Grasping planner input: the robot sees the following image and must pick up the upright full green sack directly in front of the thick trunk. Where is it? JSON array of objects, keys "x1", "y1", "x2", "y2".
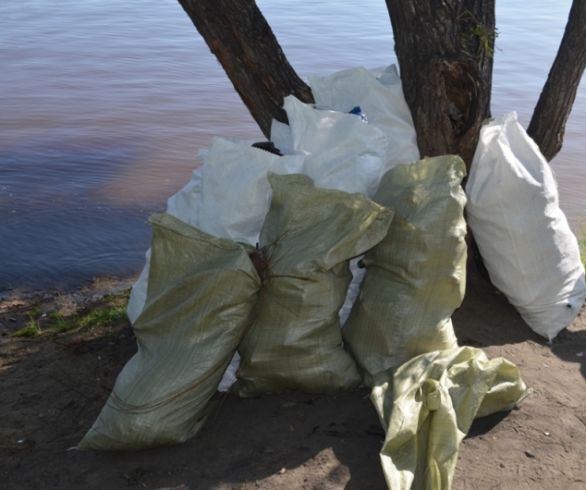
[{"x1": 343, "y1": 156, "x2": 466, "y2": 386}]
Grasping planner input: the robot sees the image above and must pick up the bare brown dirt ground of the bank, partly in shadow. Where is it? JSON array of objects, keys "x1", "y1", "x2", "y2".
[{"x1": 0, "y1": 268, "x2": 586, "y2": 490}]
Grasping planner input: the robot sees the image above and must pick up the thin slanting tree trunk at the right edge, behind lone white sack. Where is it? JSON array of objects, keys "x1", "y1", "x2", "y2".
[{"x1": 527, "y1": 0, "x2": 586, "y2": 160}]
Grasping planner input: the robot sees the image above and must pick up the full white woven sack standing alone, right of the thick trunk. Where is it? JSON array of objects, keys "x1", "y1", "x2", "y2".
[{"x1": 466, "y1": 112, "x2": 586, "y2": 340}]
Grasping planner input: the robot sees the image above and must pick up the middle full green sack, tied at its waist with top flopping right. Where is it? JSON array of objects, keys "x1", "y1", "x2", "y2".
[{"x1": 235, "y1": 174, "x2": 393, "y2": 396}]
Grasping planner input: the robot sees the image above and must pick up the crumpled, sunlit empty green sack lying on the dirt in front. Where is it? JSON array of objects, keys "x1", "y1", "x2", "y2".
[{"x1": 371, "y1": 347, "x2": 527, "y2": 490}]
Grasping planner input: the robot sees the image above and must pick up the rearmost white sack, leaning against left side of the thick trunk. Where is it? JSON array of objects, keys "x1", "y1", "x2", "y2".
[{"x1": 309, "y1": 65, "x2": 419, "y2": 170}]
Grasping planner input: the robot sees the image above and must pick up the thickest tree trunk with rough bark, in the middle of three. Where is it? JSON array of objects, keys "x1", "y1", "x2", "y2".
[{"x1": 386, "y1": 0, "x2": 495, "y2": 166}]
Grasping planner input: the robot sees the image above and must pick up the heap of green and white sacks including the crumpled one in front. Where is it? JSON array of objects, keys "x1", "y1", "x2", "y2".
[{"x1": 79, "y1": 67, "x2": 586, "y2": 489}]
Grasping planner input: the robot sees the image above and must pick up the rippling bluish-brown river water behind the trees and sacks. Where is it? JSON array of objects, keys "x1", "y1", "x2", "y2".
[{"x1": 0, "y1": 0, "x2": 586, "y2": 292}]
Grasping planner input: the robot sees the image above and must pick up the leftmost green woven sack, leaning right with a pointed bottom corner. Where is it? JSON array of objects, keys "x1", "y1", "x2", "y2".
[{"x1": 78, "y1": 214, "x2": 260, "y2": 450}]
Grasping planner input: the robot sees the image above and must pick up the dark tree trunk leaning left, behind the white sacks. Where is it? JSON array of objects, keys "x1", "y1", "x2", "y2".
[{"x1": 178, "y1": 0, "x2": 313, "y2": 137}]
